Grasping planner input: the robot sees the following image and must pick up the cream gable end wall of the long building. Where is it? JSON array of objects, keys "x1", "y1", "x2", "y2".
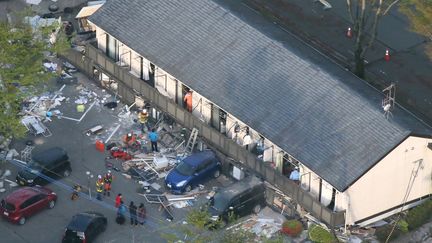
[{"x1": 337, "y1": 136, "x2": 432, "y2": 224}]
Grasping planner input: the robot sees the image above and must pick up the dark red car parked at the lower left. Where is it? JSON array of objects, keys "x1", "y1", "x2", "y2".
[{"x1": 0, "y1": 186, "x2": 57, "y2": 225}]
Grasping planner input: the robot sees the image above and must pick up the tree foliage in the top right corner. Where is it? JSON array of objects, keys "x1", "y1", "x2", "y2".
[{"x1": 399, "y1": 0, "x2": 432, "y2": 60}]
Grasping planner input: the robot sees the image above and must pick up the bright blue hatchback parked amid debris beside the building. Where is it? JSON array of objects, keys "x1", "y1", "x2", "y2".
[{"x1": 165, "y1": 150, "x2": 221, "y2": 194}]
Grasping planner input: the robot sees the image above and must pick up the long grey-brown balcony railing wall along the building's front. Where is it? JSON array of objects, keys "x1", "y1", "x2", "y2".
[{"x1": 66, "y1": 45, "x2": 345, "y2": 227}]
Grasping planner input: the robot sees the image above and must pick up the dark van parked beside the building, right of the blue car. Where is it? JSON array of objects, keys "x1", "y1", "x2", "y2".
[{"x1": 208, "y1": 176, "x2": 265, "y2": 225}]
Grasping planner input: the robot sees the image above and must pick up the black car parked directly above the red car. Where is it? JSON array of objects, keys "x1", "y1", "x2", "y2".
[{"x1": 16, "y1": 147, "x2": 72, "y2": 186}]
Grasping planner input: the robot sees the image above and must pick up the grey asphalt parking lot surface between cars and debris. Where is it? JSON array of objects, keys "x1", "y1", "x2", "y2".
[{"x1": 0, "y1": 70, "x2": 231, "y2": 242}]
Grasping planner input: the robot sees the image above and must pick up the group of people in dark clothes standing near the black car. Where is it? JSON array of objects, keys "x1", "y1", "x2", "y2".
[{"x1": 115, "y1": 193, "x2": 146, "y2": 226}]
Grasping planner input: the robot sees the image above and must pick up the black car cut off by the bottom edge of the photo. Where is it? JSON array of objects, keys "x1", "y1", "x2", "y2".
[{"x1": 62, "y1": 212, "x2": 108, "y2": 243}]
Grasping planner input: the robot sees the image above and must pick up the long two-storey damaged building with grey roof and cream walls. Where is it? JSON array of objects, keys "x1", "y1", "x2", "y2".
[{"x1": 64, "y1": 0, "x2": 432, "y2": 226}]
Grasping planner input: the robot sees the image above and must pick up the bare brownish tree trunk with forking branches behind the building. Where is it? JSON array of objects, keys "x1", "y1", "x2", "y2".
[{"x1": 346, "y1": 0, "x2": 399, "y2": 78}]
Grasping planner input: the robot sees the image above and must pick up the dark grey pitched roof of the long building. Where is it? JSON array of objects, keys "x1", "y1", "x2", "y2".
[{"x1": 90, "y1": 0, "x2": 431, "y2": 191}]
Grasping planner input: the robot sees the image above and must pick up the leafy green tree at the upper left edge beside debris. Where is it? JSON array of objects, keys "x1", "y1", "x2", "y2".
[{"x1": 0, "y1": 9, "x2": 67, "y2": 137}]
